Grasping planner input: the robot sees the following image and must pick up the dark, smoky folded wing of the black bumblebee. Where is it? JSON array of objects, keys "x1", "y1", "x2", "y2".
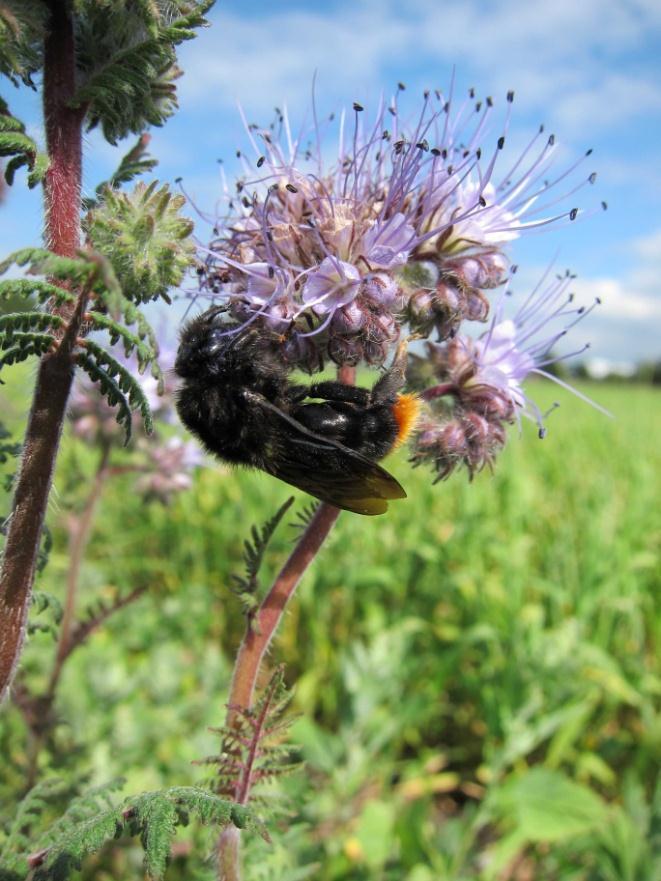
[{"x1": 248, "y1": 392, "x2": 406, "y2": 514}]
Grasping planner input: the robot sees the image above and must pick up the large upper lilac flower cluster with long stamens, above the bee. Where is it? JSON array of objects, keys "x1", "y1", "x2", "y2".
[{"x1": 187, "y1": 83, "x2": 594, "y2": 370}]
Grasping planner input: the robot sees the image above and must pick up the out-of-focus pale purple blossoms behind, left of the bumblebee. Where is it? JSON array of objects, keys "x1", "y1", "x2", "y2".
[{"x1": 68, "y1": 344, "x2": 204, "y2": 503}]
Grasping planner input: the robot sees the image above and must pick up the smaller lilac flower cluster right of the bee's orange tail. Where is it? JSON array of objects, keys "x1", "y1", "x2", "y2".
[{"x1": 411, "y1": 274, "x2": 608, "y2": 477}]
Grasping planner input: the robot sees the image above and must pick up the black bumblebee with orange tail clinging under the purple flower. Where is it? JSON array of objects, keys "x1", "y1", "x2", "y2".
[{"x1": 175, "y1": 309, "x2": 418, "y2": 514}]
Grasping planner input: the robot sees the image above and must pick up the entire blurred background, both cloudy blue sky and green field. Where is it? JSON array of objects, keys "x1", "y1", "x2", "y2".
[{"x1": 0, "y1": 0, "x2": 661, "y2": 881}]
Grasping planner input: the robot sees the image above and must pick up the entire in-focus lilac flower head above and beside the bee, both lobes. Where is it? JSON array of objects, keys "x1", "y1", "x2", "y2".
[{"x1": 188, "y1": 86, "x2": 595, "y2": 476}]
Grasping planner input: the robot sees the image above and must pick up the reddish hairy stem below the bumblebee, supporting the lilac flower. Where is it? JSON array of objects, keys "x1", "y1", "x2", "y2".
[{"x1": 218, "y1": 367, "x2": 356, "y2": 881}]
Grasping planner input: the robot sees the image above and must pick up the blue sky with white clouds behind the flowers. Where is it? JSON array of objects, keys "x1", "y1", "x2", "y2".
[{"x1": 0, "y1": 0, "x2": 661, "y2": 361}]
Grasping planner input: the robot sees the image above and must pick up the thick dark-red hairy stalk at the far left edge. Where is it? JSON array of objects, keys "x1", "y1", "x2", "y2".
[{"x1": 0, "y1": 0, "x2": 87, "y2": 699}]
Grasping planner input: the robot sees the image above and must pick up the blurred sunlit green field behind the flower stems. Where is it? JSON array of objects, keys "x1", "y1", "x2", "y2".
[{"x1": 0, "y1": 384, "x2": 661, "y2": 881}]
